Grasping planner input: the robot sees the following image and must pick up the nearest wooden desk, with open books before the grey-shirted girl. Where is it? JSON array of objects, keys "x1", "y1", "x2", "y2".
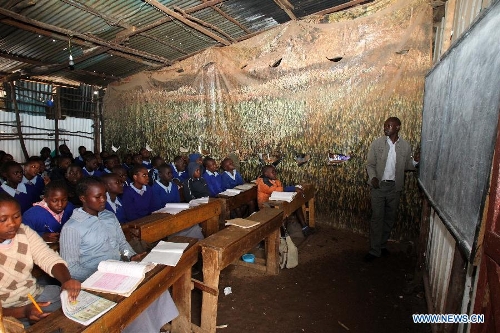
[{"x1": 26, "y1": 237, "x2": 200, "y2": 333}]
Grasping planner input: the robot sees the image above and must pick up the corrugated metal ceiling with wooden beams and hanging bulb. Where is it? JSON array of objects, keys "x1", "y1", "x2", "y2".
[{"x1": 0, "y1": 0, "x2": 373, "y2": 87}]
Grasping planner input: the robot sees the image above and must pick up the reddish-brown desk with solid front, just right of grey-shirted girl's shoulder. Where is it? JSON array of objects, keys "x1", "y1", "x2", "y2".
[{"x1": 122, "y1": 199, "x2": 222, "y2": 243}]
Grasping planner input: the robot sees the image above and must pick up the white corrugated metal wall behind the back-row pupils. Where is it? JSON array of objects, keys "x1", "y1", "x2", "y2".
[{"x1": 0, "y1": 111, "x2": 94, "y2": 162}]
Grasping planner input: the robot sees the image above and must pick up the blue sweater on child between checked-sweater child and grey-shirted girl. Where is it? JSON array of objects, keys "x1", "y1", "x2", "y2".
[{"x1": 23, "y1": 202, "x2": 75, "y2": 237}]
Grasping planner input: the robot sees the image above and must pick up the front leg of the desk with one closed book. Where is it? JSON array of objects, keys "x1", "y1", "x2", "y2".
[{"x1": 201, "y1": 248, "x2": 220, "y2": 333}]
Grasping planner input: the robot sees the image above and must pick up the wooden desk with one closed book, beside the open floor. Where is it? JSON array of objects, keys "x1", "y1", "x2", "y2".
[{"x1": 199, "y1": 208, "x2": 283, "y2": 332}]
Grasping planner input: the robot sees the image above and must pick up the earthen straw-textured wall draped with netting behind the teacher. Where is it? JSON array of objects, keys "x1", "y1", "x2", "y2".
[{"x1": 104, "y1": 0, "x2": 432, "y2": 238}]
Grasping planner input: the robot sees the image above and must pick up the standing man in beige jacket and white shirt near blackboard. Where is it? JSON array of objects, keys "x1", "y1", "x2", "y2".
[{"x1": 364, "y1": 117, "x2": 419, "y2": 262}]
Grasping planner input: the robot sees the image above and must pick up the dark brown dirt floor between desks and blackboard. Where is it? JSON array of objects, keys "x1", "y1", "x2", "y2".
[{"x1": 193, "y1": 220, "x2": 430, "y2": 333}]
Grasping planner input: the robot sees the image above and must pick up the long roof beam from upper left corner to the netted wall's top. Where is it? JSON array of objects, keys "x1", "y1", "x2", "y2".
[{"x1": 0, "y1": 8, "x2": 171, "y2": 65}]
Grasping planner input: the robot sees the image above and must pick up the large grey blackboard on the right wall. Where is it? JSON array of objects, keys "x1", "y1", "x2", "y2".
[{"x1": 419, "y1": 1, "x2": 500, "y2": 258}]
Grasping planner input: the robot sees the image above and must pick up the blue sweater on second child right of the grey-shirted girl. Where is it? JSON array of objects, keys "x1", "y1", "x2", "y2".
[{"x1": 122, "y1": 184, "x2": 153, "y2": 221}]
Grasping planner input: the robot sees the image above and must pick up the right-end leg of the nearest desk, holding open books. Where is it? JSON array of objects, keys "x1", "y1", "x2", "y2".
[{"x1": 172, "y1": 269, "x2": 191, "y2": 333}]
